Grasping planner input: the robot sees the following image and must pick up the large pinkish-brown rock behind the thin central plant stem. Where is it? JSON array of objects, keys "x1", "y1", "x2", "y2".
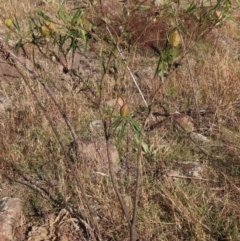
[{"x1": 71, "y1": 137, "x2": 119, "y2": 174}]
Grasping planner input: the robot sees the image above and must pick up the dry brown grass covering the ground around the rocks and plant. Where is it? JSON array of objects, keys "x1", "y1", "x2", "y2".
[{"x1": 0, "y1": 1, "x2": 240, "y2": 241}]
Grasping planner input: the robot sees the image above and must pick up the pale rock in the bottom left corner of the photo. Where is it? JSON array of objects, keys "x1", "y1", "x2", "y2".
[{"x1": 0, "y1": 197, "x2": 21, "y2": 241}]
